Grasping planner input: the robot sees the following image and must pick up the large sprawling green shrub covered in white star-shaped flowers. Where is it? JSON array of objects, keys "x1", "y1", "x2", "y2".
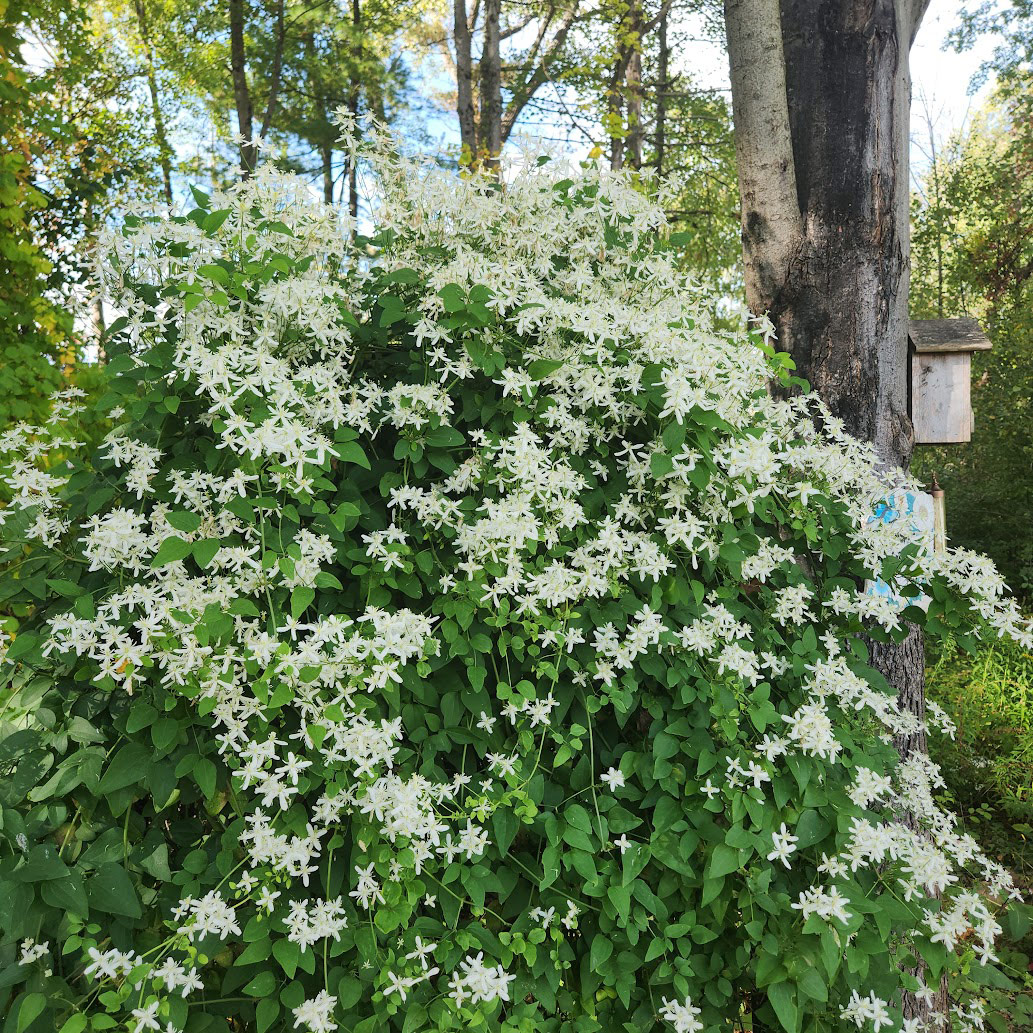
[{"x1": 0, "y1": 129, "x2": 1030, "y2": 1033}]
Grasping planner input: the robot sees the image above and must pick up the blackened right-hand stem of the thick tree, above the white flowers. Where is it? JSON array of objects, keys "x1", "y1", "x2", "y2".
[{"x1": 776, "y1": 0, "x2": 913, "y2": 468}]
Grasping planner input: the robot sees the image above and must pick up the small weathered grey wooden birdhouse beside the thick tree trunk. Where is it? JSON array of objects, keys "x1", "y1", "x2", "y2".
[{"x1": 908, "y1": 318, "x2": 991, "y2": 445}]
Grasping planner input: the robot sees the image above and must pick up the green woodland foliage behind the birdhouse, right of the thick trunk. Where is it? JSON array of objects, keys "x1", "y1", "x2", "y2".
[{"x1": 911, "y1": 99, "x2": 1033, "y2": 596}]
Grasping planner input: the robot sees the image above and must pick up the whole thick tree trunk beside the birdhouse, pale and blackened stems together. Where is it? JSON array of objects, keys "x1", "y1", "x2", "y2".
[{"x1": 725, "y1": 0, "x2": 945, "y2": 1015}]
